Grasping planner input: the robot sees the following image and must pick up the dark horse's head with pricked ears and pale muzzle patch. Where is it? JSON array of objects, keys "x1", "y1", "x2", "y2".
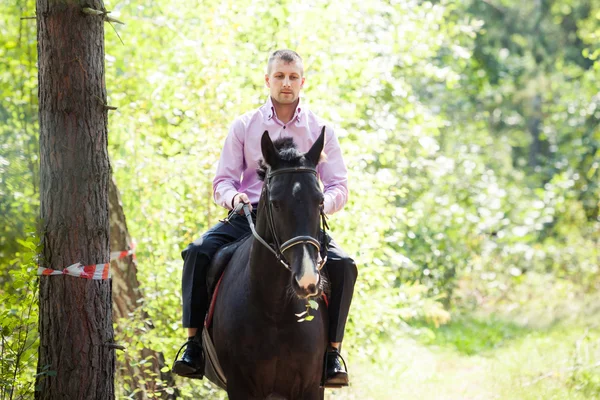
[{"x1": 259, "y1": 127, "x2": 325, "y2": 298}]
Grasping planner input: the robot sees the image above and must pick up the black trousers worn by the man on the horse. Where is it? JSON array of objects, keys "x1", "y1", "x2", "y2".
[{"x1": 181, "y1": 208, "x2": 358, "y2": 342}]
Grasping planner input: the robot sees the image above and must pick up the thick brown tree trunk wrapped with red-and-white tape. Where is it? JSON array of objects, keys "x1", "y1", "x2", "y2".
[{"x1": 35, "y1": 0, "x2": 115, "y2": 400}]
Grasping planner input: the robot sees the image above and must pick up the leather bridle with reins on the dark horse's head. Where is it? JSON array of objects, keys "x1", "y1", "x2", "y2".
[{"x1": 233, "y1": 167, "x2": 329, "y2": 271}]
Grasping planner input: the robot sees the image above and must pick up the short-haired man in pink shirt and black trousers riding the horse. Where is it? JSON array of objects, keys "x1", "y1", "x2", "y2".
[{"x1": 173, "y1": 50, "x2": 358, "y2": 386}]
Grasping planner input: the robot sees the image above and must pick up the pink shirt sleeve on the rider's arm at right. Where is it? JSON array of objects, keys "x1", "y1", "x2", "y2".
[{"x1": 317, "y1": 128, "x2": 348, "y2": 214}]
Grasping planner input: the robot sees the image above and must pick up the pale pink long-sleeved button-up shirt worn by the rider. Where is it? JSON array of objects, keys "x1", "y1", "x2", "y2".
[{"x1": 213, "y1": 97, "x2": 348, "y2": 214}]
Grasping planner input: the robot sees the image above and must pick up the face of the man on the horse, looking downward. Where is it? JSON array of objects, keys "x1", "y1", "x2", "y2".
[{"x1": 265, "y1": 59, "x2": 304, "y2": 104}]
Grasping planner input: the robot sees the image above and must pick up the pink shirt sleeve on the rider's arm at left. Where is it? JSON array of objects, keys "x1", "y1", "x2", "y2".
[{"x1": 213, "y1": 119, "x2": 245, "y2": 210}]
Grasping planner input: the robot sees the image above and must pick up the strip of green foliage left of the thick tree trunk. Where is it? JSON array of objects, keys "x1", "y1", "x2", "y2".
[{"x1": 0, "y1": 1, "x2": 39, "y2": 399}]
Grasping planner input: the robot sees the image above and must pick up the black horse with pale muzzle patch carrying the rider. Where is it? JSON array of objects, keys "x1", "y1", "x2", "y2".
[{"x1": 205, "y1": 128, "x2": 328, "y2": 400}]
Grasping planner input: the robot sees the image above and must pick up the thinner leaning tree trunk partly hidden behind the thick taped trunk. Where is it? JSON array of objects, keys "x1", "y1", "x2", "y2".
[{"x1": 108, "y1": 179, "x2": 178, "y2": 400}]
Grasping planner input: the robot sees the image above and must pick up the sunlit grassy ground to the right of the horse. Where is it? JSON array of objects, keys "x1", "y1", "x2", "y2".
[{"x1": 326, "y1": 276, "x2": 600, "y2": 400}]
